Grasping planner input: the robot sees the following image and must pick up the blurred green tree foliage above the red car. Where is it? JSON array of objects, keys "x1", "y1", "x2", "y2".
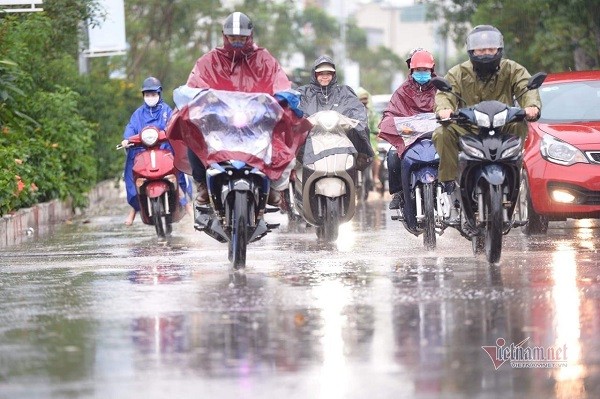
[{"x1": 426, "y1": 0, "x2": 600, "y2": 72}]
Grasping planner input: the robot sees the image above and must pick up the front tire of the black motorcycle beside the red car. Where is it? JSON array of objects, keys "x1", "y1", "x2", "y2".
[{"x1": 484, "y1": 184, "x2": 504, "y2": 263}]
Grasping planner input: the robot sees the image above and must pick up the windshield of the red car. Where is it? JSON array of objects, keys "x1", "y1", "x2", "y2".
[{"x1": 539, "y1": 81, "x2": 600, "y2": 122}]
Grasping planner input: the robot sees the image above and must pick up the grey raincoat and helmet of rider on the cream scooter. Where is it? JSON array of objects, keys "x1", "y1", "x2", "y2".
[{"x1": 298, "y1": 56, "x2": 375, "y2": 158}]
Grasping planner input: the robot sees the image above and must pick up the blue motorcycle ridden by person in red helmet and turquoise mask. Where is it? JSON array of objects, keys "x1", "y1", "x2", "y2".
[{"x1": 392, "y1": 112, "x2": 446, "y2": 250}]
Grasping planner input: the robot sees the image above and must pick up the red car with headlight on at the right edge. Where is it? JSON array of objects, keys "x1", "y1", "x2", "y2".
[{"x1": 520, "y1": 70, "x2": 600, "y2": 234}]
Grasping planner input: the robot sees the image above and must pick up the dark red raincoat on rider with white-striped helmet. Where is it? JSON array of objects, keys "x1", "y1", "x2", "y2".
[{"x1": 167, "y1": 36, "x2": 312, "y2": 180}]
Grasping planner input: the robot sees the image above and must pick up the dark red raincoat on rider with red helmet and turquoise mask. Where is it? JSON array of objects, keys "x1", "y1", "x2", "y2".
[{"x1": 378, "y1": 74, "x2": 436, "y2": 156}]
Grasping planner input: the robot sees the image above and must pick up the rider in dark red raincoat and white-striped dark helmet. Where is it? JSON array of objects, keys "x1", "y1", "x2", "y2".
[{"x1": 167, "y1": 12, "x2": 311, "y2": 206}]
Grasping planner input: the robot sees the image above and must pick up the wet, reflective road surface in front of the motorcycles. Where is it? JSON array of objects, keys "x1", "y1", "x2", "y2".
[{"x1": 0, "y1": 198, "x2": 600, "y2": 399}]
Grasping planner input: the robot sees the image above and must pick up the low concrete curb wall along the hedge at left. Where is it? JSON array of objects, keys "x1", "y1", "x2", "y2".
[{"x1": 0, "y1": 180, "x2": 122, "y2": 248}]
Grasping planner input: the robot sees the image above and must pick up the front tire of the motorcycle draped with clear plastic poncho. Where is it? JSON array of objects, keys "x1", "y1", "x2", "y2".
[{"x1": 228, "y1": 191, "x2": 249, "y2": 270}]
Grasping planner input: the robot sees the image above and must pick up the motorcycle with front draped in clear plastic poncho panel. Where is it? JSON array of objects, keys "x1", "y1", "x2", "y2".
[{"x1": 168, "y1": 88, "x2": 308, "y2": 270}]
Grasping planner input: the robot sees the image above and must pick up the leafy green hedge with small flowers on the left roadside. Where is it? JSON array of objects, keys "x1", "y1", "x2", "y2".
[{"x1": 0, "y1": 4, "x2": 131, "y2": 216}]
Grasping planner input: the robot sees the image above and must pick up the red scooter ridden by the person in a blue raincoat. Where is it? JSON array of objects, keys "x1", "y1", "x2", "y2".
[{"x1": 116, "y1": 126, "x2": 186, "y2": 238}]
